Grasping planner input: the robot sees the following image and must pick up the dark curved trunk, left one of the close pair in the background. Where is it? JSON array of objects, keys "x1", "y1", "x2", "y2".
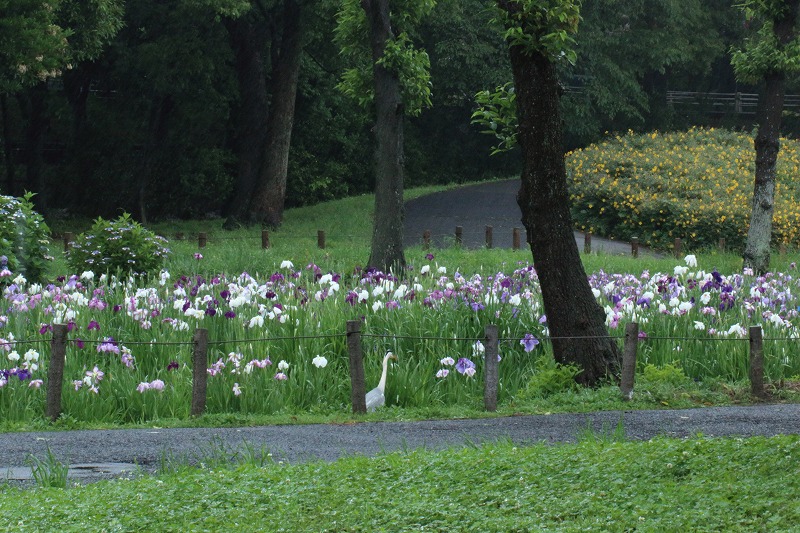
[{"x1": 224, "y1": 18, "x2": 269, "y2": 229}]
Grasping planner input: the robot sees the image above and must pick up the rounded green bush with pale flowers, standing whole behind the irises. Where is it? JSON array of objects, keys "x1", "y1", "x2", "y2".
[{"x1": 67, "y1": 213, "x2": 169, "y2": 275}]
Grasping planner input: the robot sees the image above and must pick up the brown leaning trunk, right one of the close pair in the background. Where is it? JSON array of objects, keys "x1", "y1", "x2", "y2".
[{"x1": 248, "y1": 0, "x2": 303, "y2": 228}]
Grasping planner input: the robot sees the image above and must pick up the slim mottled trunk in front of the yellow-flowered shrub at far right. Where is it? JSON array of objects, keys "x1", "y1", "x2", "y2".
[{"x1": 742, "y1": 0, "x2": 800, "y2": 274}]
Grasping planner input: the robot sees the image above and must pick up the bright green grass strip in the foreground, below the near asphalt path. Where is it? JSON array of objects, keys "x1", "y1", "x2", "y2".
[{"x1": 0, "y1": 431, "x2": 800, "y2": 532}]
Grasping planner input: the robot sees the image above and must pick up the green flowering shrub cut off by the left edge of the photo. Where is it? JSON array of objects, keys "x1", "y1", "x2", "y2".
[{"x1": 0, "y1": 193, "x2": 53, "y2": 282}]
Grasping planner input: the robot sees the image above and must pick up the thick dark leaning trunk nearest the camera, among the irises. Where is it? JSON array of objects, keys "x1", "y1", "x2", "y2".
[{"x1": 510, "y1": 46, "x2": 619, "y2": 385}]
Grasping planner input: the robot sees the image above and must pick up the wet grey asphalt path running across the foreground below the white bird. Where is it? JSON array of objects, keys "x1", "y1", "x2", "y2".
[{"x1": 0, "y1": 404, "x2": 800, "y2": 483}]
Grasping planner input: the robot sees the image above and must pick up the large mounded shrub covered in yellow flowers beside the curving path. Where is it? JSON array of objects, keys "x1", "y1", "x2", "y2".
[{"x1": 567, "y1": 128, "x2": 800, "y2": 254}]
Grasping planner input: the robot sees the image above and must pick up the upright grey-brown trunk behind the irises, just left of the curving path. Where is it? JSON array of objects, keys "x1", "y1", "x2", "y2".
[{"x1": 361, "y1": 0, "x2": 406, "y2": 275}]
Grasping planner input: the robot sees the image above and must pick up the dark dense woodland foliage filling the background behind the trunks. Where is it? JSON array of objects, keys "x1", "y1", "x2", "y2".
[{"x1": 0, "y1": 0, "x2": 776, "y2": 220}]
